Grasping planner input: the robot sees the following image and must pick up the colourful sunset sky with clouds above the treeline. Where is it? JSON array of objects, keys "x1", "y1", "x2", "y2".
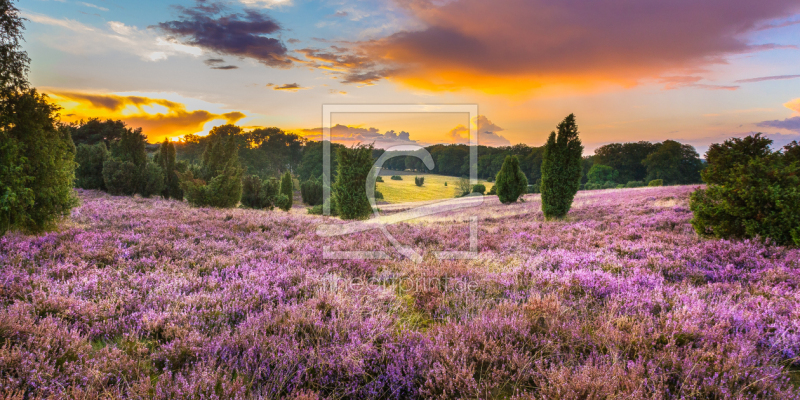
[{"x1": 17, "y1": 0, "x2": 800, "y2": 154}]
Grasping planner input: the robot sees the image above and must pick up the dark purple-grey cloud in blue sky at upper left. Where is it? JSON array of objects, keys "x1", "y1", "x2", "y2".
[{"x1": 156, "y1": 1, "x2": 292, "y2": 68}]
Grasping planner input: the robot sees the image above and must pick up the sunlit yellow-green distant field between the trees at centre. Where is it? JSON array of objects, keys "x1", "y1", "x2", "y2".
[{"x1": 378, "y1": 171, "x2": 494, "y2": 203}]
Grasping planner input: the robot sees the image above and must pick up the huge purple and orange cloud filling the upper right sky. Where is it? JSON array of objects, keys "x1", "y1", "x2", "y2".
[{"x1": 346, "y1": 0, "x2": 800, "y2": 92}]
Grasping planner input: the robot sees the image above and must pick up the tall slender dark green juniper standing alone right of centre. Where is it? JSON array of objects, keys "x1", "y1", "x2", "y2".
[{"x1": 540, "y1": 114, "x2": 583, "y2": 219}]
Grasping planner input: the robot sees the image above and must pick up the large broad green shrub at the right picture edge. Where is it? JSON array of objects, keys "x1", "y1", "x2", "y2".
[{"x1": 690, "y1": 134, "x2": 800, "y2": 246}]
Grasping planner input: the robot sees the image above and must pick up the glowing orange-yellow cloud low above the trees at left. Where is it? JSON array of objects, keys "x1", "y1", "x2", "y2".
[{"x1": 48, "y1": 90, "x2": 246, "y2": 142}]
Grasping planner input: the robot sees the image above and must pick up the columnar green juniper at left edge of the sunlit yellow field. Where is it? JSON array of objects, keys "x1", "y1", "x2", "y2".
[{"x1": 331, "y1": 144, "x2": 373, "y2": 219}]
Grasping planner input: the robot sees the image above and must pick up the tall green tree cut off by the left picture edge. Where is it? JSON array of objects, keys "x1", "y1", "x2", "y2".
[{"x1": 0, "y1": 0, "x2": 77, "y2": 235}]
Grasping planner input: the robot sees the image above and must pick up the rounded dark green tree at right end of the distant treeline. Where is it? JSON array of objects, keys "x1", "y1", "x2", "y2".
[{"x1": 642, "y1": 140, "x2": 703, "y2": 184}]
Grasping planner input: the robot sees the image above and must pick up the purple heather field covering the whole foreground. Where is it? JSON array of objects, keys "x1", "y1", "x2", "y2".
[{"x1": 0, "y1": 186, "x2": 800, "y2": 399}]
